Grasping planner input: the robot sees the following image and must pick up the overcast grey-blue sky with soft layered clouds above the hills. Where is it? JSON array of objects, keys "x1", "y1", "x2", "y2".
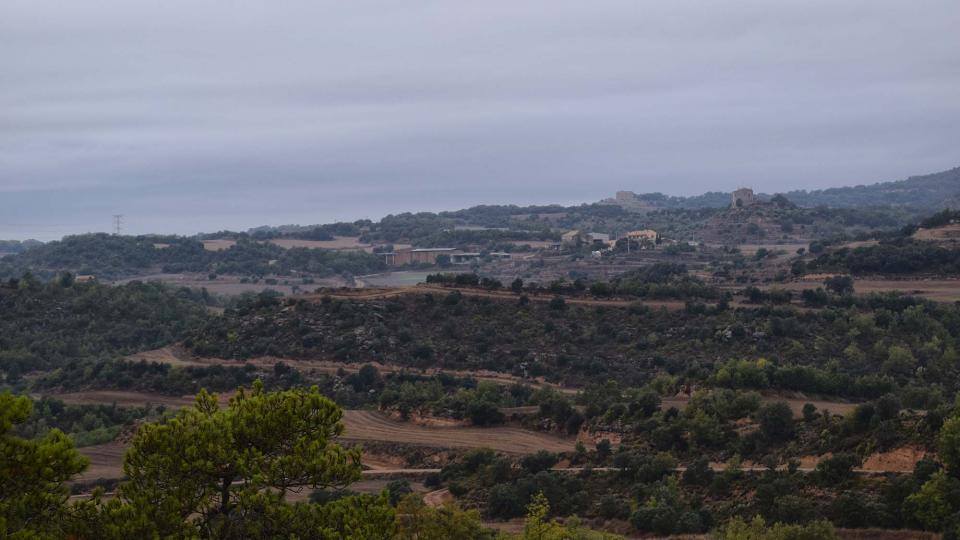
[{"x1": 0, "y1": 0, "x2": 960, "y2": 240}]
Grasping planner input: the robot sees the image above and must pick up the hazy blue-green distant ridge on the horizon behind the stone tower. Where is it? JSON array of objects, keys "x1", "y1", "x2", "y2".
[{"x1": 601, "y1": 167, "x2": 960, "y2": 211}]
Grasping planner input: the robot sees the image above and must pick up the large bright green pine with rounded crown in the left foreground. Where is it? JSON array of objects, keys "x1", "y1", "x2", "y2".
[{"x1": 104, "y1": 381, "x2": 360, "y2": 538}]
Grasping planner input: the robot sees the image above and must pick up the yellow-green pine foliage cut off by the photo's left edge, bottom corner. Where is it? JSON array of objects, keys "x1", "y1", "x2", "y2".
[{"x1": 0, "y1": 393, "x2": 88, "y2": 538}]
